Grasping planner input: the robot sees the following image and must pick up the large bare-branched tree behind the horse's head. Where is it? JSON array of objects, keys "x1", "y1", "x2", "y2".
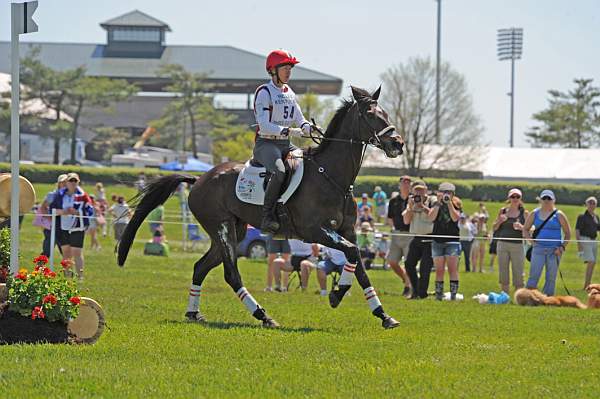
[{"x1": 381, "y1": 57, "x2": 483, "y2": 173}]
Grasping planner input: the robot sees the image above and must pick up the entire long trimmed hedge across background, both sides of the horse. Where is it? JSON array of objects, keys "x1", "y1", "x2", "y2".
[{"x1": 0, "y1": 163, "x2": 600, "y2": 205}]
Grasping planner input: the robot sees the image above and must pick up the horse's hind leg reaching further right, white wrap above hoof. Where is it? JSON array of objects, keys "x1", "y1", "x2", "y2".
[{"x1": 218, "y1": 221, "x2": 279, "y2": 327}]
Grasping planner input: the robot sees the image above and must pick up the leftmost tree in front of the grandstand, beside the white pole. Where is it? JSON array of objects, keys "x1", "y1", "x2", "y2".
[{"x1": 21, "y1": 48, "x2": 85, "y2": 164}]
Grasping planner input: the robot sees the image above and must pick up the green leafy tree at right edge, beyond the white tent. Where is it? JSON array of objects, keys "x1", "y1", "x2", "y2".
[{"x1": 525, "y1": 79, "x2": 600, "y2": 148}]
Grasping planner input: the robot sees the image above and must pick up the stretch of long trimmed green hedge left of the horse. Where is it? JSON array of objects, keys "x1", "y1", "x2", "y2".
[{"x1": 0, "y1": 163, "x2": 193, "y2": 185}]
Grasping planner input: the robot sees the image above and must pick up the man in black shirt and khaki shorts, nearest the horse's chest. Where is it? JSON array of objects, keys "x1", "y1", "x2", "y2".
[{"x1": 387, "y1": 176, "x2": 420, "y2": 297}]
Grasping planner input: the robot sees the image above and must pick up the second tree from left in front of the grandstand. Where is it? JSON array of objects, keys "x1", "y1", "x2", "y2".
[{"x1": 67, "y1": 76, "x2": 137, "y2": 161}]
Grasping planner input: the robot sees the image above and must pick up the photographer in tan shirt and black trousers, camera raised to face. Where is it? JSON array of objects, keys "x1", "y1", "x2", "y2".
[{"x1": 400, "y1": 181, "x2": 435, "y2": 299}]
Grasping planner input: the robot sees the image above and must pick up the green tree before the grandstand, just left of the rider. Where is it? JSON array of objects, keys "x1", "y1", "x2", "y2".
[{"x1": 155, "y1": 64, "x2": 212, "y2": 158}]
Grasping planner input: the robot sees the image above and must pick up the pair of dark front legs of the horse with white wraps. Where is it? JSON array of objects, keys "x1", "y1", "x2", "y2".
[{"x1": 320, "y1": 227, "x2": 399, "y2": 328}]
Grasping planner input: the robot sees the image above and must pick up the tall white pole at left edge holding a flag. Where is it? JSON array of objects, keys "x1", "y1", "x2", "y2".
[{"x1": 10, "y1": 3, "x2": 20, "y2": 275}]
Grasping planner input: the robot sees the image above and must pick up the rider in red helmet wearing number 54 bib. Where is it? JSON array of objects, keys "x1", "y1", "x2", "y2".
[{"x1": 253, "y1": 50, "x2": 312, "y2": 234}]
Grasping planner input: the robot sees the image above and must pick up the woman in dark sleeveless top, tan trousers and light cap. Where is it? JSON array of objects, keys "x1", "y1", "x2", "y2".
[{"x1": 494, "y1": 188, "x2": 529, "y2": 293}]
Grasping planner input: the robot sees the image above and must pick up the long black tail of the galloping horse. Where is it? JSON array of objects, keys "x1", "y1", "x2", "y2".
[{"x1": 117, "y1": 175, "x2": 196, "y2": 266}]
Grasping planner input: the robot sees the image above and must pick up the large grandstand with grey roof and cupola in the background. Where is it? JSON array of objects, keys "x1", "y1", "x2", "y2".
[{"x1": 0, "y1": 10, "x2": 342, "y2": 164}]
